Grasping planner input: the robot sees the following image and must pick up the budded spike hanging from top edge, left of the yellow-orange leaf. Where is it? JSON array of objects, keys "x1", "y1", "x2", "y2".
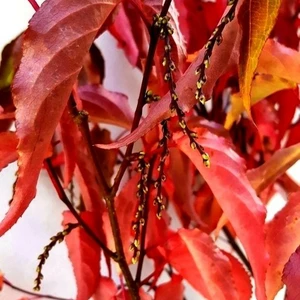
[{"x1": 195, "y1": 0, "x2": 238, "y2": 105}]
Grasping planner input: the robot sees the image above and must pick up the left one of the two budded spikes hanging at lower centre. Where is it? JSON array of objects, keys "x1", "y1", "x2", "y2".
[{"x1": 130, "y1": 152, "x2": 150, "y2": 264}]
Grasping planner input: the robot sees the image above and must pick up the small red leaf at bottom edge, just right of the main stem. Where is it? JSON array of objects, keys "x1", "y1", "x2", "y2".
[{"x1": 154, "y1": 274, "x2": 184, "y2": 300}]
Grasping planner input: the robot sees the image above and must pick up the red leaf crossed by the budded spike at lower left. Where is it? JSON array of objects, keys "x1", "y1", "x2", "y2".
[{"x1": 63, "y1": 211, "x2": 100, "y2": 300}]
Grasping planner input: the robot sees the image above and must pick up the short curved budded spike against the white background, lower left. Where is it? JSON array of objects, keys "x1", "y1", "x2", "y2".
[{"x1": 33, "y1": 224, "x2": 79, "y2": 291}]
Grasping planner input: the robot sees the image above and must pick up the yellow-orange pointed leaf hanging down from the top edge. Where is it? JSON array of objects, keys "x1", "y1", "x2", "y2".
[{"x1": 238, "y1": 0, "x2": 281, "y2": 115}]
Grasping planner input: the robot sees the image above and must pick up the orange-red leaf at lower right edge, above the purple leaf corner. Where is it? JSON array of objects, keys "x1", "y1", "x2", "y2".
[{"x1": 266, "y1": 192, "x2": 300, "y2": 299}]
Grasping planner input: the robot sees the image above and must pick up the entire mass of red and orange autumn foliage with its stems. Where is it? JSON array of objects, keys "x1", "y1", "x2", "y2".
[{"x1": 0, "y1": 0, "x2": 300, "y2": 300}]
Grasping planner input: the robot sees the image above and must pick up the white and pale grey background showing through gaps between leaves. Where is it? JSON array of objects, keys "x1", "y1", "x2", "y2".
[{"x1": 0, "y1": 0, "x2": 292, "y2": 300}]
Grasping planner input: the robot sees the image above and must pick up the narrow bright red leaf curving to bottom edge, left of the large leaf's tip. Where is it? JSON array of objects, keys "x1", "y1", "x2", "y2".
[{"x1": 222, "y1": 251, "x2": 252, "y2": 300}]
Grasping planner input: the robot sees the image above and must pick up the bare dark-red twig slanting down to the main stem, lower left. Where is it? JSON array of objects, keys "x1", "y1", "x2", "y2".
[{"x1": 44, "y1": 158, "x2": 117, "y2": 260}]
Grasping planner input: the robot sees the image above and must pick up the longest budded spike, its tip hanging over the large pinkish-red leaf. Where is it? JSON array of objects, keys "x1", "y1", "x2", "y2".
[{"x1": 154, "y1": 16, "x2": 210, "y2": 167}]
